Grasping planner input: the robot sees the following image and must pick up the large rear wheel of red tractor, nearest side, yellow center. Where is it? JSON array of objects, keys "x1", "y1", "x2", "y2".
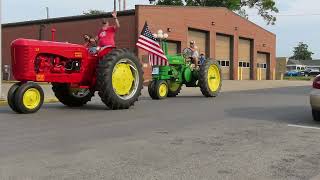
[{"x1": 97, "y1": 49, "x2": 143, "y2": 109}]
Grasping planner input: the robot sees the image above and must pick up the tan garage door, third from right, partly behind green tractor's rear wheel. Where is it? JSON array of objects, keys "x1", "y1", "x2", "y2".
[{"x1": 216, "y1": 35, "x2": 231, "y2": 79}]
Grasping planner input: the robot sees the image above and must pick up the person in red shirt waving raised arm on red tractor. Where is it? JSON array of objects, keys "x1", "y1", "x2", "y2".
[{"x1": 96, "y1": 11, "x2": 120, "y2": 48}]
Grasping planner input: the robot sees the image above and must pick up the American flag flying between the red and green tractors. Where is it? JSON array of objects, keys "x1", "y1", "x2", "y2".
[{"x1": 137, "y1": 22, "x2": 169, "y2": 66}]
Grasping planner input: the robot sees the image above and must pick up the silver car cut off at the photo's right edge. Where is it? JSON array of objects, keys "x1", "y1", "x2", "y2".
[{"x1": 310, "y1": 75, "x2": 320, "y2": 121}]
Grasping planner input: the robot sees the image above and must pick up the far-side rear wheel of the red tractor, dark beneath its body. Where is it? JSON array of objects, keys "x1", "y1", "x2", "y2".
[{"x1": 52, "y1": 83, "x2": 94, "y2": 107}]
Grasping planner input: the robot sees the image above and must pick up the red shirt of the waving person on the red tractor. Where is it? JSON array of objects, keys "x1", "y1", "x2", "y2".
[{"x1": 98, "y1": 26, "x2": 116, "y2": 47}]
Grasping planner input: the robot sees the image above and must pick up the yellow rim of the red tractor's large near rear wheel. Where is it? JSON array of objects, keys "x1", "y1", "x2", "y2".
[{"x1": 112, "y1": 63, "x2": 135, "y2": 96}]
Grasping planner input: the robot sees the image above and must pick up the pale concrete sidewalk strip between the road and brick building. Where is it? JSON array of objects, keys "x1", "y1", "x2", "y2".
[{"x1": 0, "y1": 80, "x2": 312, "y2": 105}]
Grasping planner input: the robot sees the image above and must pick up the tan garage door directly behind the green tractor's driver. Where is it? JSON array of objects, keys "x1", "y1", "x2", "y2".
[{"x1": 188, "y1": 30, "x2": 209, "y2": 55}]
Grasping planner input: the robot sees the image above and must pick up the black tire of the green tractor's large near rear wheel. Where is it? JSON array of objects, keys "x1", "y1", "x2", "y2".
[{"x1": 199, "y1": 60, "x2": 222, "y2": 97}]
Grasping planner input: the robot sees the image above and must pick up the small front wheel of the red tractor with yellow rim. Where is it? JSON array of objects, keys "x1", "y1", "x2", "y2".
[{"x1": 10, "y1": 82, "x2": 44, "y2": 114}]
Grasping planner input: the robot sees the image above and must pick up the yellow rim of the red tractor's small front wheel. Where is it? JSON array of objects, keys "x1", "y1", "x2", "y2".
[{"x1": 23, "y1": 88, "x2": 41, "y2": 110}]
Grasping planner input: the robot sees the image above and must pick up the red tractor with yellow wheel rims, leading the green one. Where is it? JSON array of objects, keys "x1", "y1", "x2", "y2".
[{"x1": 8, "y1": 39, "x2": 143, "y2": 114}]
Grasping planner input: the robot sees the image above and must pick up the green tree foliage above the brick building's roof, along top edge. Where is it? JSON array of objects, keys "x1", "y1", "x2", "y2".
[{"x1": 156, "y1": 0, "x2": 279, "y2": 24}]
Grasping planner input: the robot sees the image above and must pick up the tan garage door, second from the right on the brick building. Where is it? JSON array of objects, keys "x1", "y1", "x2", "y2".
[{"x1": 238, "y1": 39, "x2": 251, "y2": 80}]
